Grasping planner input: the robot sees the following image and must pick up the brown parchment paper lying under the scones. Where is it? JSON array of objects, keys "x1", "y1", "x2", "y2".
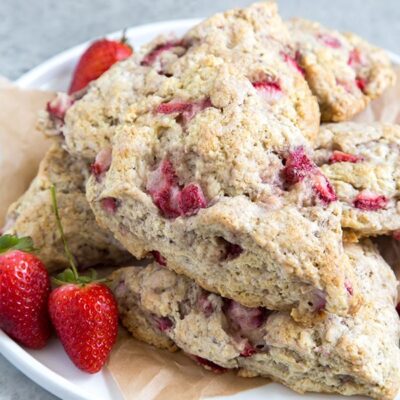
[{"x1": 0, "y1": 68, "x2": 400, "y2": 400}]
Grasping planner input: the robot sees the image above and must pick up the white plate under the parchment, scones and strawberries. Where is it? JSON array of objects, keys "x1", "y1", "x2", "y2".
[{"x1": 0, "y1": 19, "x2": 400, "y2": 400}]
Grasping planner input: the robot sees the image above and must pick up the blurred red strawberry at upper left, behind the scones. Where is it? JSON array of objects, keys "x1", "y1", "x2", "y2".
[{"x1": 68, "y1": 38, "x2": 133, "y2": 94}]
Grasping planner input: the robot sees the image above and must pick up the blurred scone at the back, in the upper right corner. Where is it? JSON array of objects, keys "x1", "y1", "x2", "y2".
[{"x1": 286, "y1": 18, "x2": 395, "y2": 122}]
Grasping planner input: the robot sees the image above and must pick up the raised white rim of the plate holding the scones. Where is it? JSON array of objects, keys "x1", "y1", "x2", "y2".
[{"x1": 4, "y1": 18, "x2": 400, "y2": 400}]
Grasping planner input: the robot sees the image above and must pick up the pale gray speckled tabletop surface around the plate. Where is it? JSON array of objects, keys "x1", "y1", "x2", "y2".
[{"x1": 0, "y1": 0, "x2": 400, "y2": 400}]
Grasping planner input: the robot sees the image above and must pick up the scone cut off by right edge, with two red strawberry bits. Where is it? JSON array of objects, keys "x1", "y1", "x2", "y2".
[{"x1": 314, "y1": 122, "x2": 400, "y2": 236}]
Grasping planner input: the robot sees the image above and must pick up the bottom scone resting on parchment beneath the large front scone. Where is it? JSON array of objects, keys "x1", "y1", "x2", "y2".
[{"x1": 113, "y1": 242, "x2": 400, "y2": 400}]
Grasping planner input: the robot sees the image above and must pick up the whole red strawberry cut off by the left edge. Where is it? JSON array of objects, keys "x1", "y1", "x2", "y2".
[{"x1": 0, "y1": 235, "x2": 51, "y2": 349}]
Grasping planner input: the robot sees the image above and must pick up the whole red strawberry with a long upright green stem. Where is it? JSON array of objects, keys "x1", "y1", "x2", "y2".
[{"x1": 49, "y1": 186, "x2": 118, "y2": 373}]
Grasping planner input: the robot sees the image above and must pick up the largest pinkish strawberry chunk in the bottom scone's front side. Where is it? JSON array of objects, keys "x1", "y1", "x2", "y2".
[{"x1": 224, "y1": 300, "x2": 267, "y2": 333}]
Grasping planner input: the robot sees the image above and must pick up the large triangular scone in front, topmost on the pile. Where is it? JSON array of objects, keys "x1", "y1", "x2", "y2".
[{"x1": 86, "y1": 55, "x2": 357, "y2": 322}]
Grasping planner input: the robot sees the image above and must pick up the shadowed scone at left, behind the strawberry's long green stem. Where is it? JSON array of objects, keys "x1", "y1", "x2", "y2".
[{"x1": 5, "y1": 142, "x2": 132, "y2": 272}]
